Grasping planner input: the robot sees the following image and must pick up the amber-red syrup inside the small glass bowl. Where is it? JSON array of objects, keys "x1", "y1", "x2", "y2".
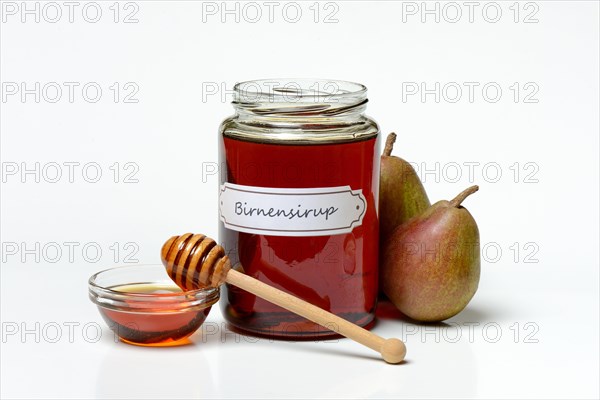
[{"x1": 98, "y1": 283, "x2": 210, "y2": 346}]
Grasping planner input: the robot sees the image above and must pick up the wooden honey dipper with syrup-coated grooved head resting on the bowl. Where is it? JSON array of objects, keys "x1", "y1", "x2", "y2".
[{"x1": 161, "y1": 233, "x2": 406, "y2": 364}]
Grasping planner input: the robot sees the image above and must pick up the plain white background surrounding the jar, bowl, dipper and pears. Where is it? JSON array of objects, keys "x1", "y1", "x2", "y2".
[{"x1": 0, "y1": 1, "x2": 599, "y2": 398}]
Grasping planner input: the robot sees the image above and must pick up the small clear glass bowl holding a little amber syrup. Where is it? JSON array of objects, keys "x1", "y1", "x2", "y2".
[{"x1": 88, "y1": 265, "x2": 219, "y2": 346}]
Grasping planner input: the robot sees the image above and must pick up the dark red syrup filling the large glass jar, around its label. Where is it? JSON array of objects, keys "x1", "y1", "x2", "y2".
[{"x1": 219, "y1": 137, "x2": 379, "y2": 338}]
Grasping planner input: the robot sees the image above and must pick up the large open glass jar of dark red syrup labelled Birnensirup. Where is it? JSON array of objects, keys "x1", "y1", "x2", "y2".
[{"x1": 219, "y1": 79, "x2": 380, "y2": 338}]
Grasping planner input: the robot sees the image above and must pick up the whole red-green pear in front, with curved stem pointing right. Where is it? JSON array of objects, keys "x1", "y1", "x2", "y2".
[{"x1": 381, "y1": 186, "x2": 481, "y2": 322}]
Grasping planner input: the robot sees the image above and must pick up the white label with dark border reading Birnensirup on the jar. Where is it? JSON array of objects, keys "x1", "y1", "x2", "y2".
[{"x1": 219, "y1": 182, "x2": 367, "y2": 236}]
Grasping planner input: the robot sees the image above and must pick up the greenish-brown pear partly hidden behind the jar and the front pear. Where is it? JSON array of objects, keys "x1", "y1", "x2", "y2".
[{"x1": 379, "y1": 132, "x2": 431, "y2": 245}]
